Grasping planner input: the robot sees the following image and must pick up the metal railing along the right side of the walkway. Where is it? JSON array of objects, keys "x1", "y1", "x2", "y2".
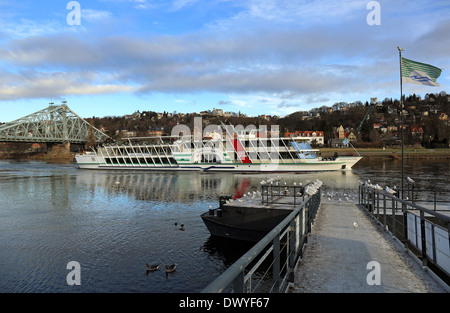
[{"x1": 358, "y1": 185, "x2": 450, "y2": 284}]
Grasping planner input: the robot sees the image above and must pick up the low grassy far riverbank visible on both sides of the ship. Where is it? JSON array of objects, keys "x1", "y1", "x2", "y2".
[{"x1": 0, "y1": 145, "x2": 450, "y2": 162}]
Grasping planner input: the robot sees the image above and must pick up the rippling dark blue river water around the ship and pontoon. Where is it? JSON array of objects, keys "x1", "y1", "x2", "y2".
[{"x1": 0, "y1": 159, "x2": 450, "y2": 293}]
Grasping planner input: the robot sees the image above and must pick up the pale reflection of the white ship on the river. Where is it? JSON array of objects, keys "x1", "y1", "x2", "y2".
[{"x1": 76, "y1": 171, "x2": 359, "y2": 203}]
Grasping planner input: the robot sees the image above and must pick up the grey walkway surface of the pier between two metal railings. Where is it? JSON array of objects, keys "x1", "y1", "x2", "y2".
[{"x1": 290, "y1": 201, "x2": 446, "y2": 293}]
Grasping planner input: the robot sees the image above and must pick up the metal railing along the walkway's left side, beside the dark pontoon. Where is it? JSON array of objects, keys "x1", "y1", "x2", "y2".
[{"x1": 202, "y1": 186, "x2": 320, "y2": 293}]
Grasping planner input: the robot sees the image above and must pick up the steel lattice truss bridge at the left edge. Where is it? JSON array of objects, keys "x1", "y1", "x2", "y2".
[{"x1": 0, "y1": 101, "x2": 109, "y2": 143}]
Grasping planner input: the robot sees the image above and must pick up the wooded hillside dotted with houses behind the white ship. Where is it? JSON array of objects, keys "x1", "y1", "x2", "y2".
[{"x1": 87, "y1": 92, "x2": 450, "y2": 148}]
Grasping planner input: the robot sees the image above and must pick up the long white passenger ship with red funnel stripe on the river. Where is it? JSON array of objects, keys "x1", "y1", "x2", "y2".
[{"x1": 75, "y1": 131, "x2": 362, "y2": 172}]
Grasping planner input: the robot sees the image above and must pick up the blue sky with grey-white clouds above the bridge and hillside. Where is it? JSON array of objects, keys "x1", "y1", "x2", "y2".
[{"x1": 0, "y1": 0, "x2": 450, "y2": 122}]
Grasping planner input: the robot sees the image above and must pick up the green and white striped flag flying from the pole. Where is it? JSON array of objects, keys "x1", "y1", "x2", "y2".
[{"x1": 402, "y1": 57, "x2": 442, "y2": 87}]
